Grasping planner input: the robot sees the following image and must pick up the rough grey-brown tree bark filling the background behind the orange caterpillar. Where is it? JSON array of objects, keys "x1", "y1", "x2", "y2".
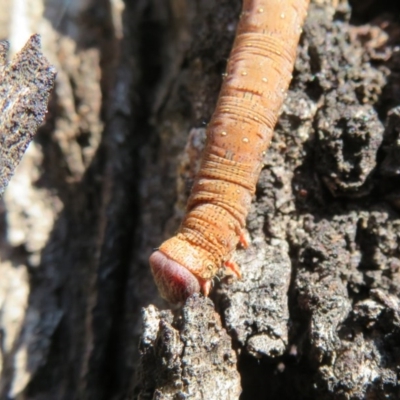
[{"x1": 0, "y1": 0, "x2": 400, "y2": 400}]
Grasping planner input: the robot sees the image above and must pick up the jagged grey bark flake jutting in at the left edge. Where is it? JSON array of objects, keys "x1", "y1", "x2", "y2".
[{"x1": 0, "y1": 35, "x2": 56, "y2": 196}]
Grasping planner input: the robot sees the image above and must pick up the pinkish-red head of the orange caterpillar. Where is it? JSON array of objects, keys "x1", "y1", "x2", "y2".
[{"x1": 149, "y1": 250, "x2": 201, "y2": 304}]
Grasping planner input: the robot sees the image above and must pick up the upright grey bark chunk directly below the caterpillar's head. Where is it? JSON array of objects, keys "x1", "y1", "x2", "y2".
[{"x1": 134, "y1": 295, "x2": 241, "y2": 400}]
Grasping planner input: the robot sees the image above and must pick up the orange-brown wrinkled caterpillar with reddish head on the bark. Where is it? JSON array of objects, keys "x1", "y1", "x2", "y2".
[{"x1": 149, "y1": 0, "x2": 309, "y2": 303}]
